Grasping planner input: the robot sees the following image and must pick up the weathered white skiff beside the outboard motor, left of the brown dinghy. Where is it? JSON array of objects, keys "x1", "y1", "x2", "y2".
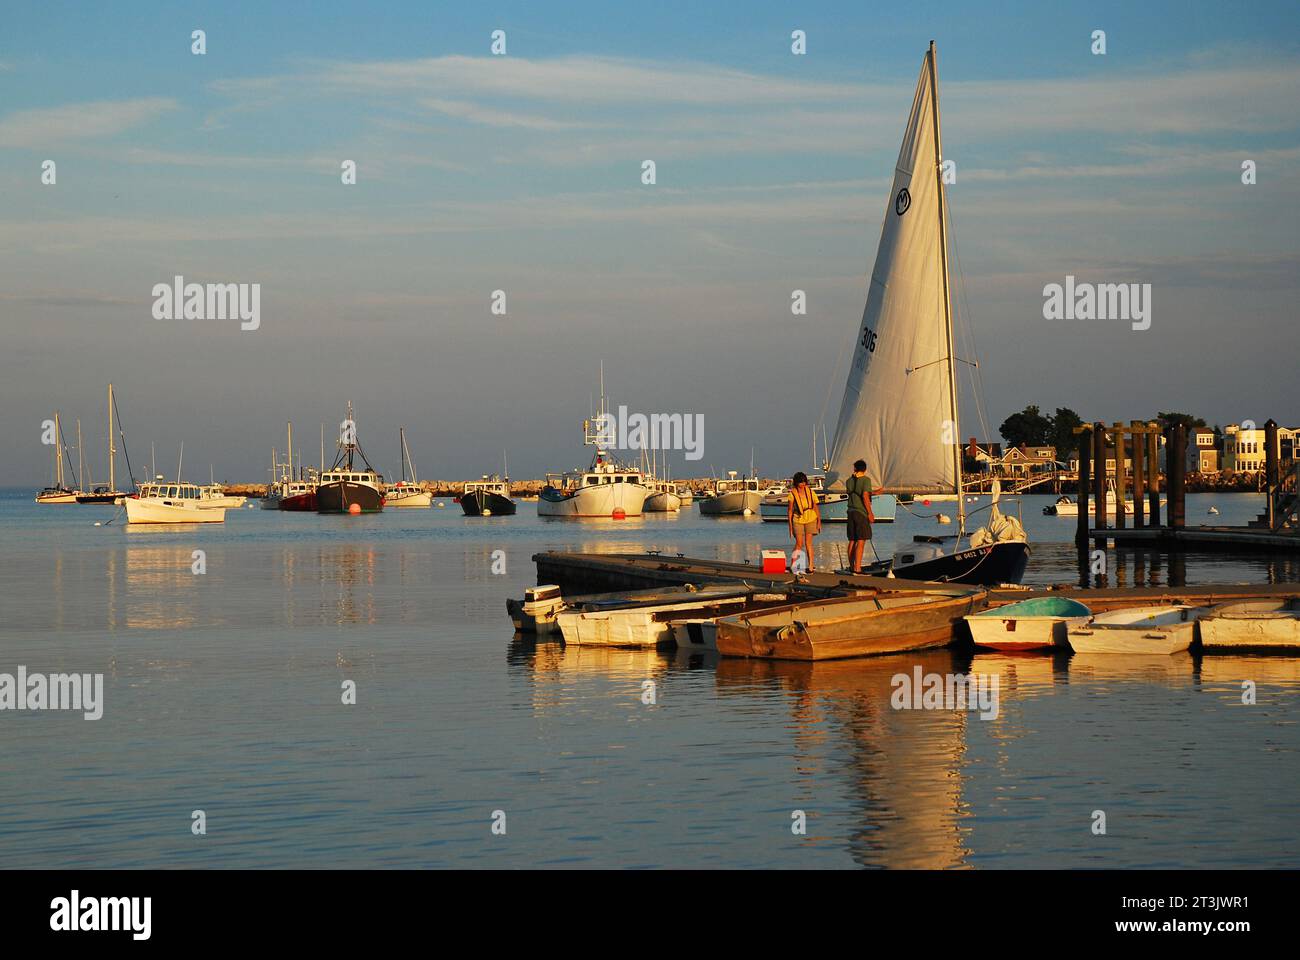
[{"x1": 556, "y1": 585, "x2": 759, "y2": 647}]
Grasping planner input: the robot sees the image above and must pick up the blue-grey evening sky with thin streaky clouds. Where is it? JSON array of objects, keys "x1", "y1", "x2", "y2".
[{"x1": 0, "y1": 3, "x2": 1300, "y2": 484}]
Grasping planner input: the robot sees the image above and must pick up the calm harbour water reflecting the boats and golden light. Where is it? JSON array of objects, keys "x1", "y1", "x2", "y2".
[{"x1": 0, "y1": 490, "x2": 1300, "y2": 868}]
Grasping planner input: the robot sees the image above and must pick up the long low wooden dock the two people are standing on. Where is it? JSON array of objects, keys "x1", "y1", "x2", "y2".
[{"x1": 533, "y1": 546, "x2": 1300, "y2": 613}]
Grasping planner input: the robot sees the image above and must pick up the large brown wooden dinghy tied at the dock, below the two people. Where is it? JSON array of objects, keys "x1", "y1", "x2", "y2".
[{"x1": 718, "y1": 588, "x2": 988, "y2": 660}]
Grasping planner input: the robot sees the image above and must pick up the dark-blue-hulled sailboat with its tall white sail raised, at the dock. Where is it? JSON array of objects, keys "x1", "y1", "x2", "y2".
[{"x1": 827, "y1": 42, "x2": 1030, "y2": 584}]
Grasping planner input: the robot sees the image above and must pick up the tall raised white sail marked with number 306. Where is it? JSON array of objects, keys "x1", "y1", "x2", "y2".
[{"x1": 827, "y1": 46, "x2": 961, "y2": 493}]
